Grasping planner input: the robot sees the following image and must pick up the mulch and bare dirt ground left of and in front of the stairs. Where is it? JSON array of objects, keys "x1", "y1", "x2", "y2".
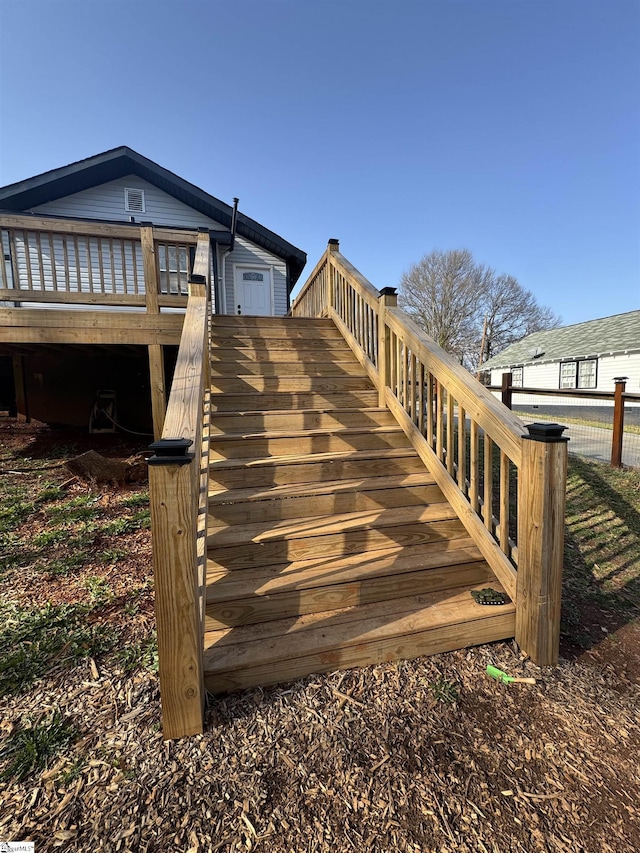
[{"x1": 0, "y1": 423, "x2": 640, "y2": 853}]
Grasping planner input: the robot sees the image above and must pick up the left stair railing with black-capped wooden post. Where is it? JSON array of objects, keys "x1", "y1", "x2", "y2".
[{"x1": 149, "y1": 234, "x2": 211, "y2": 738}]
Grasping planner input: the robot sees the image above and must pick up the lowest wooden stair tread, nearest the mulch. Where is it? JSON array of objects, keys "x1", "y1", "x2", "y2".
[{"x1": 204, "y1": 582, "x2": 515, "y2": 674}]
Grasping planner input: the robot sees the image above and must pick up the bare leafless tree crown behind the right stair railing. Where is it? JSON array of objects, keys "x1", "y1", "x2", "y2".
[{"x1": 400, "y1": 249, "x2": 560, "y2": 370}]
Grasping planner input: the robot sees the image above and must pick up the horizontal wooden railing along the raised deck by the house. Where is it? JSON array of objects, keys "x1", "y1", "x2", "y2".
[{"x1": 0, "y1": 214, "x2": 198, "y2": 312}]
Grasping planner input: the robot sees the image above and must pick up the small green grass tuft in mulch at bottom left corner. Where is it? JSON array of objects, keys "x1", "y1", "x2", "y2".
[{"x1": 0, "y1": 710, "x2": 77, "y2": 782}]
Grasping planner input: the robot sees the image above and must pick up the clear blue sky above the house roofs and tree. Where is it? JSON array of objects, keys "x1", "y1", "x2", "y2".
[{"x1": 0, "y1": 0, "x2": 640, "y2": 323}]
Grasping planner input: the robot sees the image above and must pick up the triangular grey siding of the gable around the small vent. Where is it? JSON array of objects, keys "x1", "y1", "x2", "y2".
[{"x1": 30, "y1": 175, "x2": 228, "y2": 231}]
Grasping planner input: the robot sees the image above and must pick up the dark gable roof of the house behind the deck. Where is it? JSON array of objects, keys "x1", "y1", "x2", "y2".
[{"x1": 0, "y1": 145, "x2": 307, "y2": 289}]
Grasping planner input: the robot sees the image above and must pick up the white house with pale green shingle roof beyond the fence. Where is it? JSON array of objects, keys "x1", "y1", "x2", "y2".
[{"x1": 482, "y1": 311, "x2": 640, "y2": 393}]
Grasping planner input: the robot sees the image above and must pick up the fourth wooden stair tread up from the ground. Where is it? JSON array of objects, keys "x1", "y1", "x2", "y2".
[{"x1": 209, "y1": 471, "x2": 435, "y2": 507}]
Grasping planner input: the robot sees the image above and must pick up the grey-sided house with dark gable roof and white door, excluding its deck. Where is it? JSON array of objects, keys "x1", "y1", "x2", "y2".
[{"x1": 0, "y1": 146, "x2": 307, "y2": 316}]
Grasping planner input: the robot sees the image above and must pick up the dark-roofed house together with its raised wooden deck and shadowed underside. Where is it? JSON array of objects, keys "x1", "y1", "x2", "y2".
[{"x1": 0, "y1": 146, "x2": 306, "y2": 432}]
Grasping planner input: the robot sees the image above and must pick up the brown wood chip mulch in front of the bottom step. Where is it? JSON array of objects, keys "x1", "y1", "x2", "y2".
[{"x1": 0, "y1": 422, "x2": 640, "y2": 853}]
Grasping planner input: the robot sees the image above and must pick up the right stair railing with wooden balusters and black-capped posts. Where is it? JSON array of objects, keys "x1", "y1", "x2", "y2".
[{"x1": 291, "y1": 241, "x2": 567, "y2": 665}]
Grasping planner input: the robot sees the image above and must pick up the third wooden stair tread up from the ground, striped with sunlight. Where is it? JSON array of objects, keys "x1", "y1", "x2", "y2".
[{"x1": 207, "y1": 499, "x2": 457, "y2": 548}]
